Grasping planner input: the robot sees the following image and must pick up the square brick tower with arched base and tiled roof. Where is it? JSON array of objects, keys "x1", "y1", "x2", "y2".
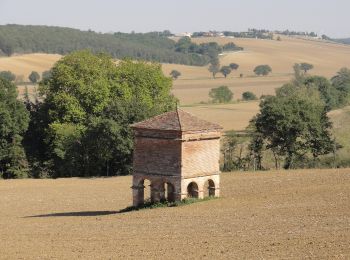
[{"x1": 132, "y1": 110, "x2": 222, "y2": 206}]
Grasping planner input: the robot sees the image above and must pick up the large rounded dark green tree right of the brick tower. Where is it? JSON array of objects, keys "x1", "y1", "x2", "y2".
[{"x1": 255, "y1": 87, "x2": 334, "y2": 169}]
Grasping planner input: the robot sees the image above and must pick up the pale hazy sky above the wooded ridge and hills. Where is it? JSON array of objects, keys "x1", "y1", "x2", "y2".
[{"x1": 0, "y1": 0, "x2": 350, "y2": 38}]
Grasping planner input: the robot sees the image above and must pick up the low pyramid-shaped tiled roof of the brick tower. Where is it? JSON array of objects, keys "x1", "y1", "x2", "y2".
[{"x1": 131, "y1": 109, "x2": 222, "y2": 132}]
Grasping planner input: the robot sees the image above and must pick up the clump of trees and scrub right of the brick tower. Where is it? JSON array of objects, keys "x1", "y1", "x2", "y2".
[{"x1": 222, "y1": 64, "x2": 350, "y2": 171}]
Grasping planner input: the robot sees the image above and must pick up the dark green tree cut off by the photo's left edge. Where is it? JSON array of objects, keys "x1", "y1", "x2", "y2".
[{"x1": 0, "y1": 78, "x2": 29, "y2": 179}]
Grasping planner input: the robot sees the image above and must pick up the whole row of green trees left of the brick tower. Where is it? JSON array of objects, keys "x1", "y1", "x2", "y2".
[{"x1": 0, "y1": 51, "x2": 176, "y2": 178}]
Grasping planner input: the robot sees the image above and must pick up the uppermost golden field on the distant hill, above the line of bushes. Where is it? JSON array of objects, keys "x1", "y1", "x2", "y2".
[{"x1": 189, "y1": 37, "x2": 350, "y2": 77}]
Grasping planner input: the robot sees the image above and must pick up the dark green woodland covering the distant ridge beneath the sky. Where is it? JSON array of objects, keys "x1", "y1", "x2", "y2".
[{"x1": 0, "y1": 25, "x2": 242, "y2": 66}]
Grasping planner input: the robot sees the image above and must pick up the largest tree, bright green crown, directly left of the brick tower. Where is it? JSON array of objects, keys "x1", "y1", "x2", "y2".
[{"x1": 35, "y1": 51, "x2": 176, "y2": 177}]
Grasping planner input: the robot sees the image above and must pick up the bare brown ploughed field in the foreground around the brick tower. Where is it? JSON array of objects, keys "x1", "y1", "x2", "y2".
[{"x1": 0, "y1": 169, "x2": 350, "y2": 259}]
